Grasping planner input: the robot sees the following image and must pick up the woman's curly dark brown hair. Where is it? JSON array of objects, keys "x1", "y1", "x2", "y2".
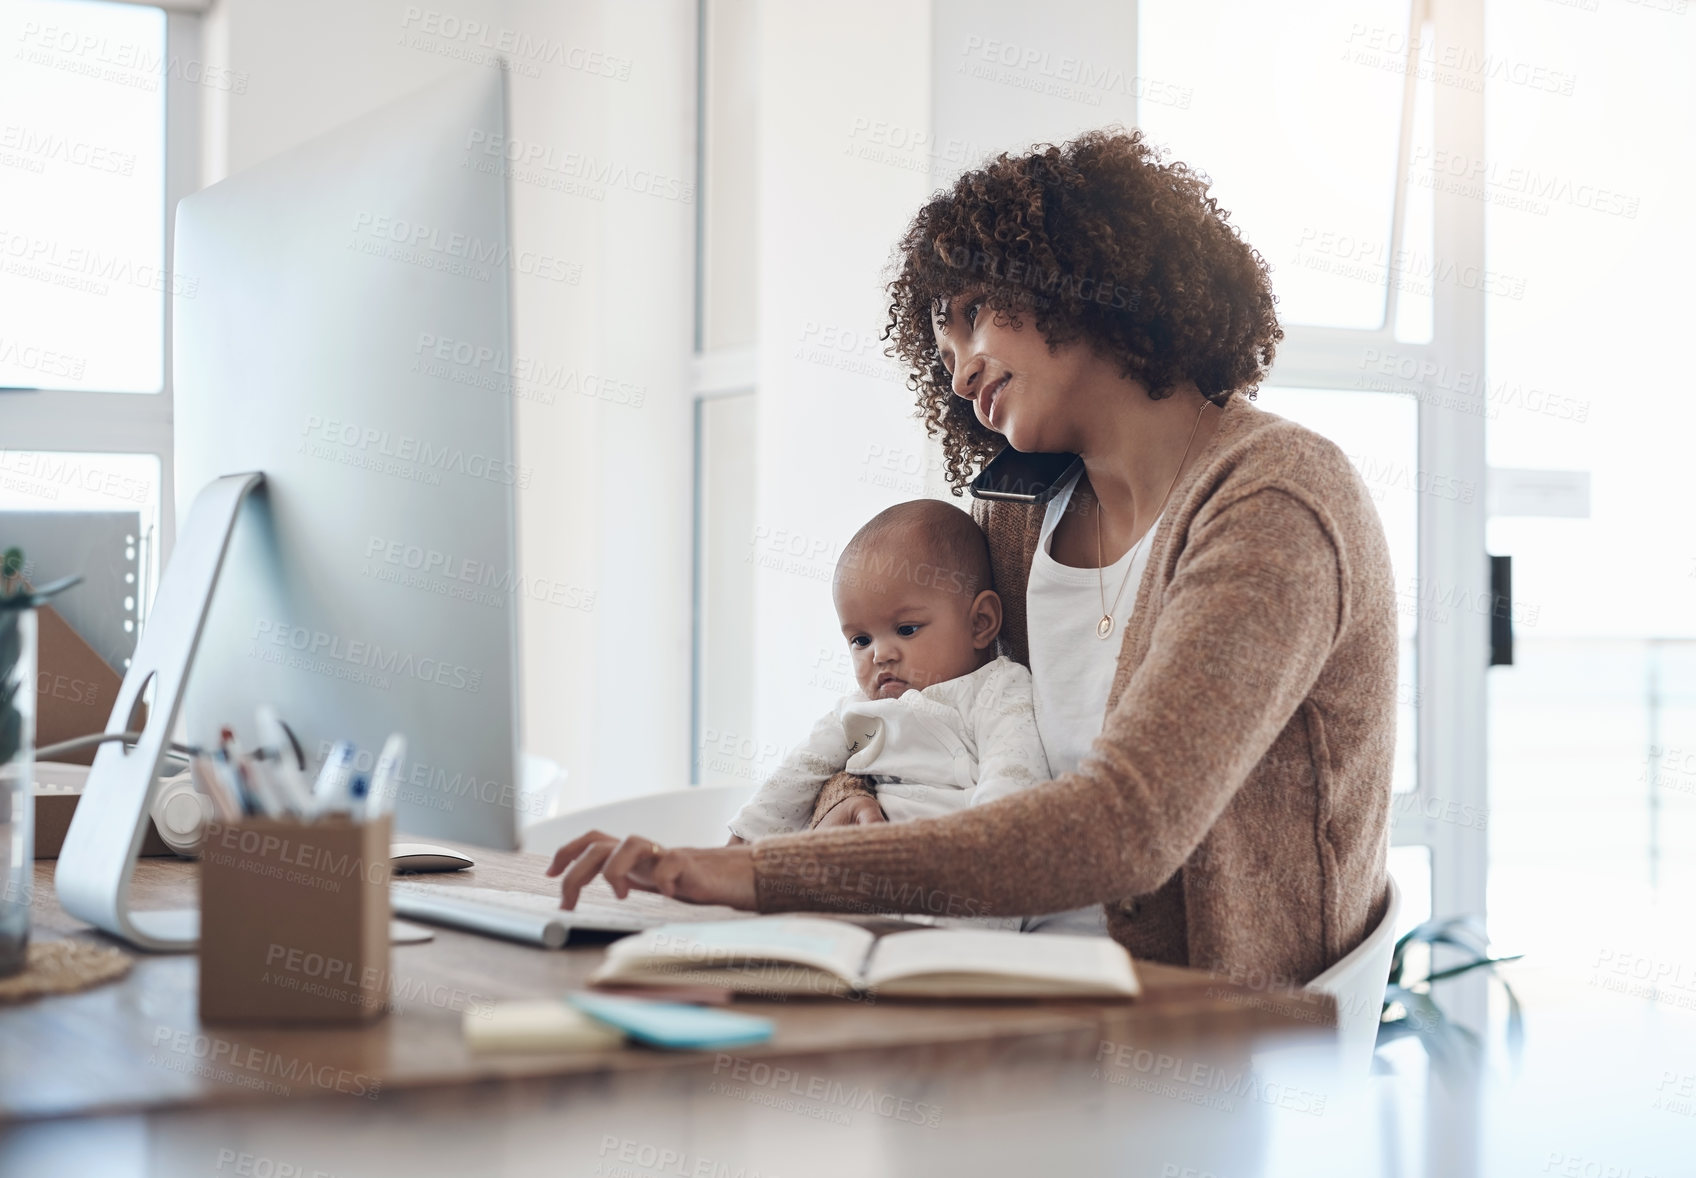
[{"x1": 882, "y1": 127, "x2": 1284, "y2": 495}]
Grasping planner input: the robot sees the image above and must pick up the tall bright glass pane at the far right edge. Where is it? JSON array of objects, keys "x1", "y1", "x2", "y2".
[{"x1": 1478, "y1": 3, "x2": 1696, "y2": 976}]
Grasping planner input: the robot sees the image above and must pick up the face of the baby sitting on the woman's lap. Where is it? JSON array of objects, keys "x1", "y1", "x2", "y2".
[{"x1": 834, "y1": 566, "x2": 996, "y2": 700}]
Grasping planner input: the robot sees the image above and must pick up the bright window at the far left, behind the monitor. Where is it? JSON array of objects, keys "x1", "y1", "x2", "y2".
[{"x1": 0, "y1": 0, "x2": 196, "y2": 589}]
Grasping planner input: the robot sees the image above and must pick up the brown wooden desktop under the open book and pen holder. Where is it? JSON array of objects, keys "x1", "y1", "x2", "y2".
[{"x1": 0, "y1": 849, "x2": 1335, "y2": 1124}]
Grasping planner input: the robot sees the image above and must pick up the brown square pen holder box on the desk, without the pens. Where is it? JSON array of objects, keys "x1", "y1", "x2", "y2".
[{"x1": 200, "y1": 815, "x2": 390, "y2": 1024}]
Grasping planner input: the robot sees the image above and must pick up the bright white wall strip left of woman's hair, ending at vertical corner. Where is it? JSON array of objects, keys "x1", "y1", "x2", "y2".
[{"x1": 748, "y1": 0, "x2": 929, "y2": 770}]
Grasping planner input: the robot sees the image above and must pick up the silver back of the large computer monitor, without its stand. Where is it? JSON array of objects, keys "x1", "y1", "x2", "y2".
[{"x1": 173, "y1": 69, "x2": 526, "y2": 847}]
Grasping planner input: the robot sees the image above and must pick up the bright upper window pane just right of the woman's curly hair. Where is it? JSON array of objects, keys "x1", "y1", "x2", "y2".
[{"x1": 1138, "y1": 0, "x2": 1431, "y2": 339}]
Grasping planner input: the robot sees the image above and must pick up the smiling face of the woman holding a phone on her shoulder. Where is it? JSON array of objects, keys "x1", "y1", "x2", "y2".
[{"x1": 931, "y1": 290, "x2": 1118, "y2": 453}]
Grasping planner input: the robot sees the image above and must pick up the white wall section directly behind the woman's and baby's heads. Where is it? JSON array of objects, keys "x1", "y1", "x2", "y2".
[{"x1": 743, "y1": 0, "x2": 1136, "y2": 770}]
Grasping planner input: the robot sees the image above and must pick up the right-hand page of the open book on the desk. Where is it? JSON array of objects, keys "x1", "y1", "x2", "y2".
[{"x1": 865, "y1": 929, "x2": 1140, "y2": 997}]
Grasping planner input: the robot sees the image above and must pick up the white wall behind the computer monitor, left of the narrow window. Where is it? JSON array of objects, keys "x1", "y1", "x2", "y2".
[{"x1": 204, "y1": 0, "x2": 695, "y2": 802}]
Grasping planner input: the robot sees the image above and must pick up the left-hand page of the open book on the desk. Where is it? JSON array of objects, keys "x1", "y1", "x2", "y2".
[{"x1": 595, "y1": 915, "x2": 875, "y2": 988}]
